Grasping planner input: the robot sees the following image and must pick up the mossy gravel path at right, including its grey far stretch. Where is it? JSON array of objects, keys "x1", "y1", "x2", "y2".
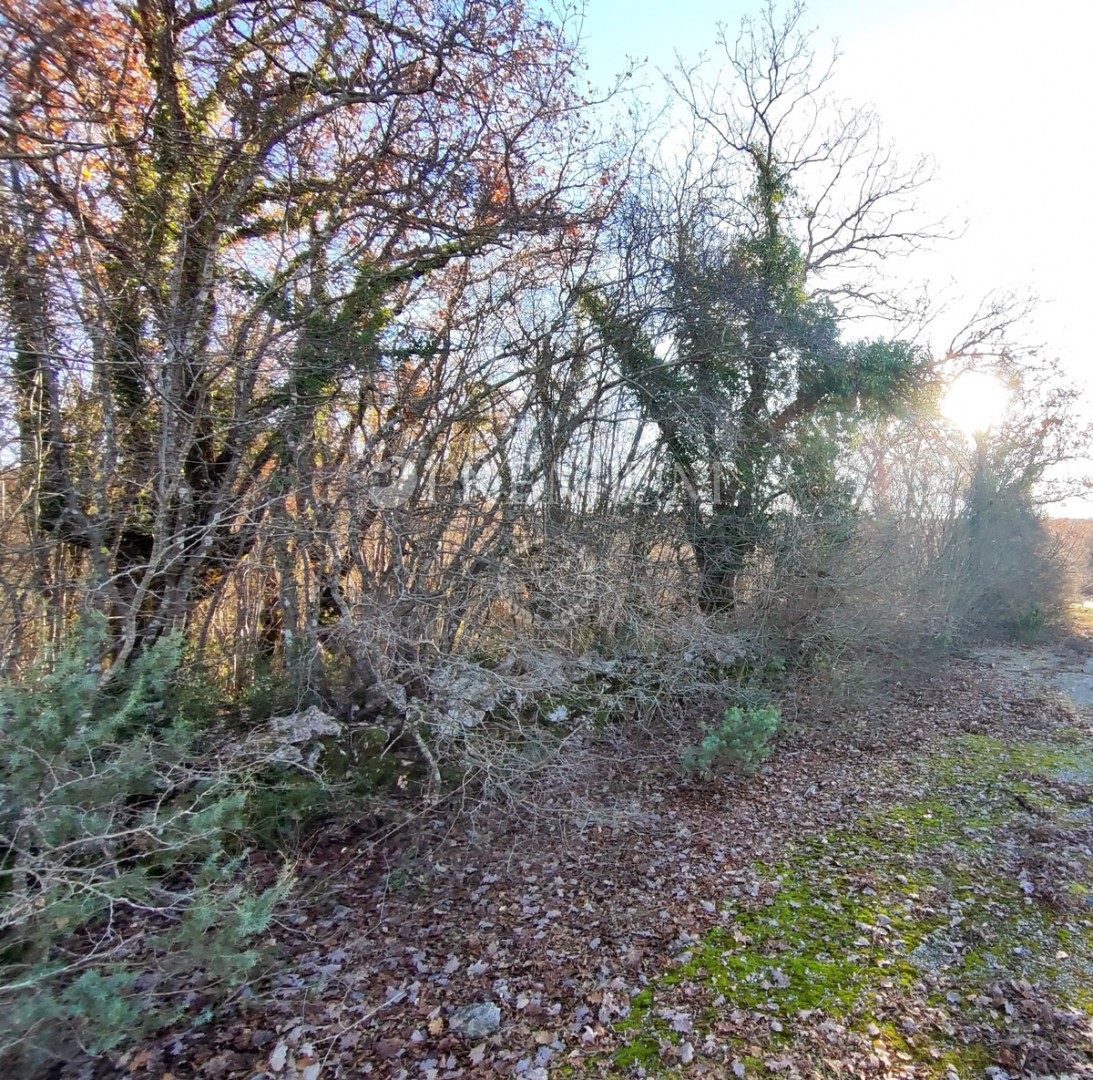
[{"x1": 594, "y1": 648, "x2": 1093, "y2": 1080}]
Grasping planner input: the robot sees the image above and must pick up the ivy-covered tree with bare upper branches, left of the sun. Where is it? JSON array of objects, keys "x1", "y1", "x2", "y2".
[{"x1": 588, "y1": 5, "x2": 937, "y2": 610}]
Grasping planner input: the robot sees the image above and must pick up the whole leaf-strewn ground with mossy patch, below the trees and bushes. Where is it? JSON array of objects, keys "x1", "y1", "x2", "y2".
[{"x1": 108, "y1": 645, "x2": 1093, "y2": 1080}]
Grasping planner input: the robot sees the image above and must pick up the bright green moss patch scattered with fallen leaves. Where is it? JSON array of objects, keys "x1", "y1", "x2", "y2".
[{"x1": 613, "y1": 736, "x2": 1093, "y2": 1080}]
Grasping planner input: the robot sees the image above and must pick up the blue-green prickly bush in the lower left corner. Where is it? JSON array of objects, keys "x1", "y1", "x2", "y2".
[{"x1": 0, "y1": 624, "x2": 289, "y2": 1076}]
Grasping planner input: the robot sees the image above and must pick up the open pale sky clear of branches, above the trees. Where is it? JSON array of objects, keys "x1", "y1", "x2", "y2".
[{"x1": 584, "y1": 0, "x2": 1093, "y2": 514}]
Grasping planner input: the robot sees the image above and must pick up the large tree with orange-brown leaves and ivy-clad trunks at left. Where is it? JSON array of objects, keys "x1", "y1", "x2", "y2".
[{"x1": 0, "y1": 0, "x2": 606, "y2": 662}]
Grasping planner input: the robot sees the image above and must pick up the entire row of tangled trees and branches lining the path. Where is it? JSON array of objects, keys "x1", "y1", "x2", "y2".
[{"x1": 0, "y1": 0, "x2": 1080, "y2": 1062}]
